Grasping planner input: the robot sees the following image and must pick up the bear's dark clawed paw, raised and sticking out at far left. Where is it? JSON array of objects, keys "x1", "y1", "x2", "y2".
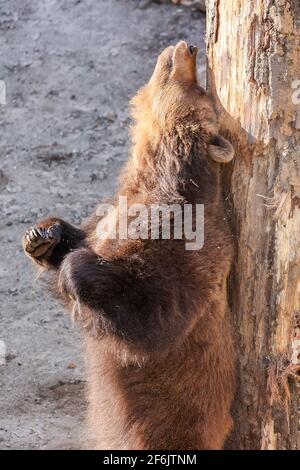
[{"x1": 23, "y1": 222, "x2": 62, "y2": 259}]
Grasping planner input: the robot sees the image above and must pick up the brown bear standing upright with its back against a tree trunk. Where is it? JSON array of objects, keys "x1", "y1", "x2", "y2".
[{"x1": 23, "y1": 41, "x2": 235, "y2": 450}]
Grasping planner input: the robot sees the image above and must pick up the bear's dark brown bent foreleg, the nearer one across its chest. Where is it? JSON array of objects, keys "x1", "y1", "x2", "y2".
[{"x1": 58, "y1": 248, "x2": 192, "y2": 353}]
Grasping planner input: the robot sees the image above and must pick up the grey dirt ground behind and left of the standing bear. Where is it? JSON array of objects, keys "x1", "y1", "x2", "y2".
[{"x1": 0, "y1": 0, "x2": 205, "y2": 449}]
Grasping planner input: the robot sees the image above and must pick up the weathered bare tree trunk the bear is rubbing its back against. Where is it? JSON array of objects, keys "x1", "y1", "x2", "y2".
[{"x1": 207, "y1": 0, "x2": 300, "y2": 449}]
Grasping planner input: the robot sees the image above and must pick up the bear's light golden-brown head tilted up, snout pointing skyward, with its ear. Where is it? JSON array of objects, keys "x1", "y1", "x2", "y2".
[{"x1": 132, "y1": 41, "x2": 234, "y2": 163}]
